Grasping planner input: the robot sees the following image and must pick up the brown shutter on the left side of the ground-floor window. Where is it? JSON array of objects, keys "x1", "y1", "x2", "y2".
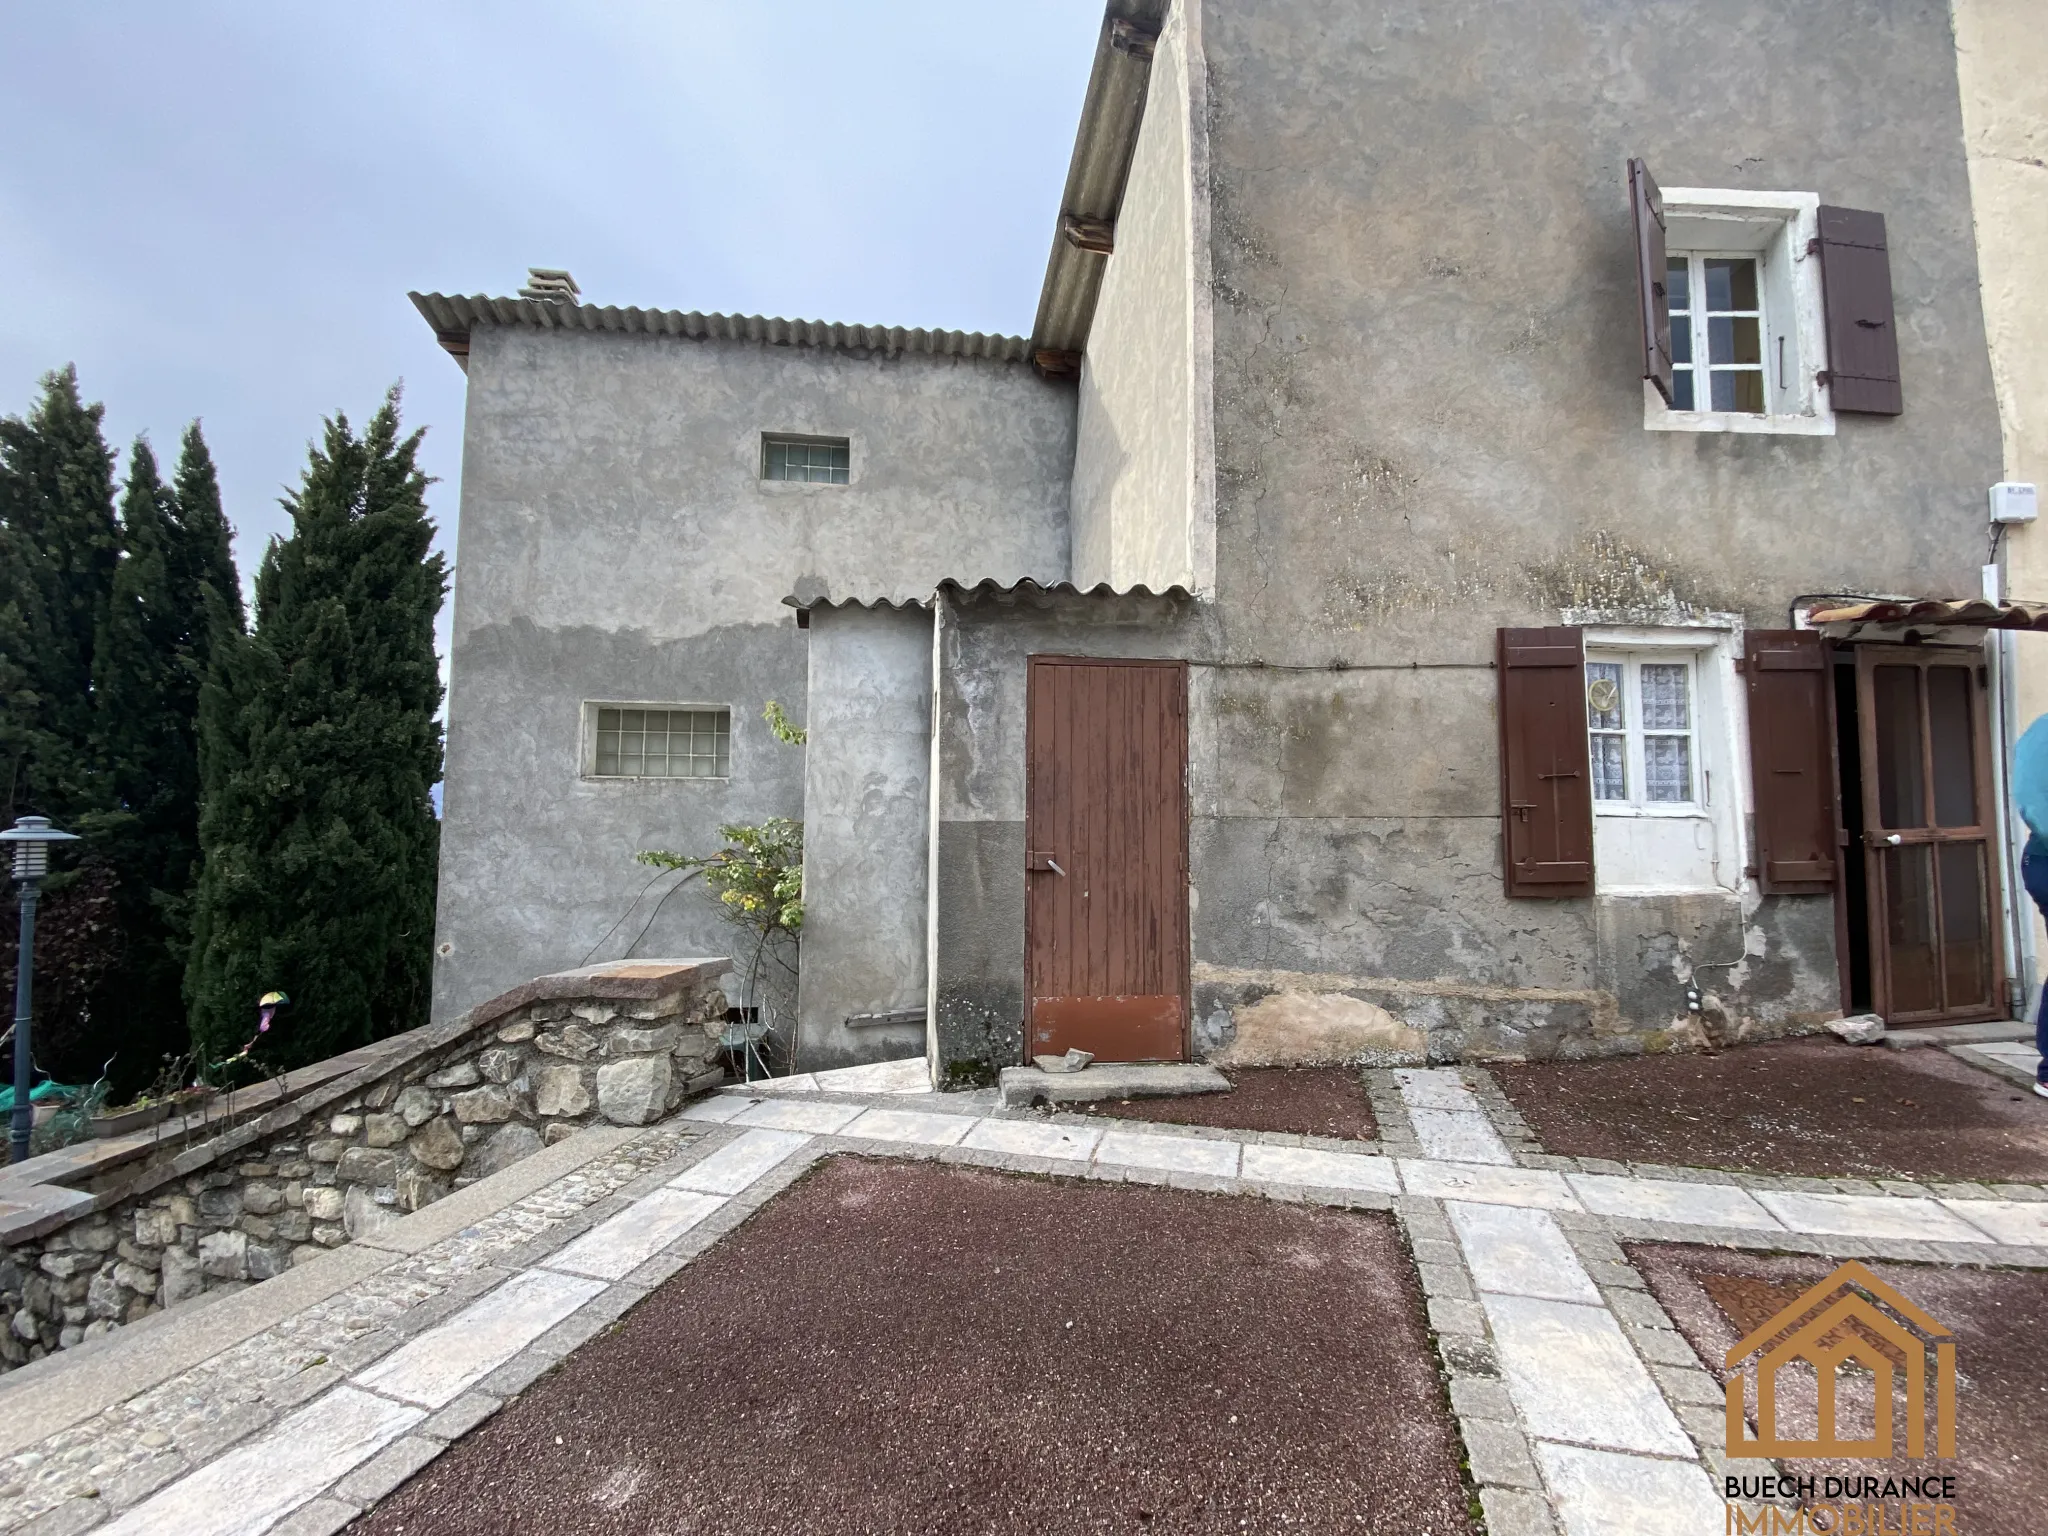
[{"x1": 1499, "y1": 629, "x2": 1593, "y2": 897}]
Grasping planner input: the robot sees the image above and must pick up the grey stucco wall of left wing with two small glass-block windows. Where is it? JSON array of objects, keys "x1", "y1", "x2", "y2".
[{"x1": 434, "y1": 328, "x2": 1073, "y2": 1018}]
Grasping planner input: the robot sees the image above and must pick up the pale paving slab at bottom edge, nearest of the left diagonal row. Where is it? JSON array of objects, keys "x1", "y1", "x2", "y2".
[{"x1": 104, "y1": 1386, "x2": 426, "y2": 1536}]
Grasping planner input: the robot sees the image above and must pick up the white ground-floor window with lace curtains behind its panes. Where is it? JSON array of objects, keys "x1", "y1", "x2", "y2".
[{"x1": 1585, "y1": 651, "x2": 1698, "y2": 811}]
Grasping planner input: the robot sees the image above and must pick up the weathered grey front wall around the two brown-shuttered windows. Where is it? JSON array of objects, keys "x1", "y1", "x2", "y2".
[{"x1": 1155, "y1": 0, "x2": 1999, "y2": 1055}]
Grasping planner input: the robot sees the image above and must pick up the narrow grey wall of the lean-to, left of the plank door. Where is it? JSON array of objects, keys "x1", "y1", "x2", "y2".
[{"x1": 797, "y1": 608, "x2": 932, "y2": 1071}]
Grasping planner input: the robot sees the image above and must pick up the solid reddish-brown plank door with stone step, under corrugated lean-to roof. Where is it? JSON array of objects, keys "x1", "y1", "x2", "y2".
[{"x1": 1024, "y1": 655, "x2": 1188, "y2": 1061}]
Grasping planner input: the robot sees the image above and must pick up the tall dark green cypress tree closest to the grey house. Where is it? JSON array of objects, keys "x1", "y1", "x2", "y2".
[{"x1": 184, "y1": 387, "x2": 446, "y2": 1065}]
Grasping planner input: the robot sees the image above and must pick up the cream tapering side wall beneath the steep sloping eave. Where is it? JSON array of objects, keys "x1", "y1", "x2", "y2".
[{"x1": 1073, "y1": 2, "x2": 1206, "y2": 590}]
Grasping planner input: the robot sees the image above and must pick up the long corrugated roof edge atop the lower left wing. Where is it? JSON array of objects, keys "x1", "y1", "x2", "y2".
[{"x1": 408, "y1": 293, "x2": 1030, "y2": 362}]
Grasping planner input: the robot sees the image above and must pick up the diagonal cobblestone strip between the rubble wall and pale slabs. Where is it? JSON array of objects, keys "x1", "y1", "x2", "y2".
[{"x1": 0, "y1": 1122, "x2": 709, "y2": 1536}]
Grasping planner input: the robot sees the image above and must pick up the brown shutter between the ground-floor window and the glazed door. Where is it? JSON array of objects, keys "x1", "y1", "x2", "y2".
[{"x1": 1743, "y1": 629, "x2": 1841, "y2": 895}]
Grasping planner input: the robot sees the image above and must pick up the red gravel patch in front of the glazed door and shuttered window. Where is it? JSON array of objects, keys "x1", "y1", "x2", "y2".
[{"x1": 1493, "y1": 1040, "x2": 2048, "y2": 1182}]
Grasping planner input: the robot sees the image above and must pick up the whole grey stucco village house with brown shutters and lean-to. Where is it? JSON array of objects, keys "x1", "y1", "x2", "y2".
[{"x1": 414, "y1": 0, "x2": 2048, "y2": 1083}]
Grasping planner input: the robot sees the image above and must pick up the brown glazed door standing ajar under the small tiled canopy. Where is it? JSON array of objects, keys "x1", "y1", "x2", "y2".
[{"x1": 1855, "y1": 645, "x2": 2003, "y2": 1024}]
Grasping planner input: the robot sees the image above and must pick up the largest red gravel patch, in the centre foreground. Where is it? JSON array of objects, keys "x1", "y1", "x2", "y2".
[{"x1": 352, "y1": 1157, "x2": 1470, "y2": 1536}]
